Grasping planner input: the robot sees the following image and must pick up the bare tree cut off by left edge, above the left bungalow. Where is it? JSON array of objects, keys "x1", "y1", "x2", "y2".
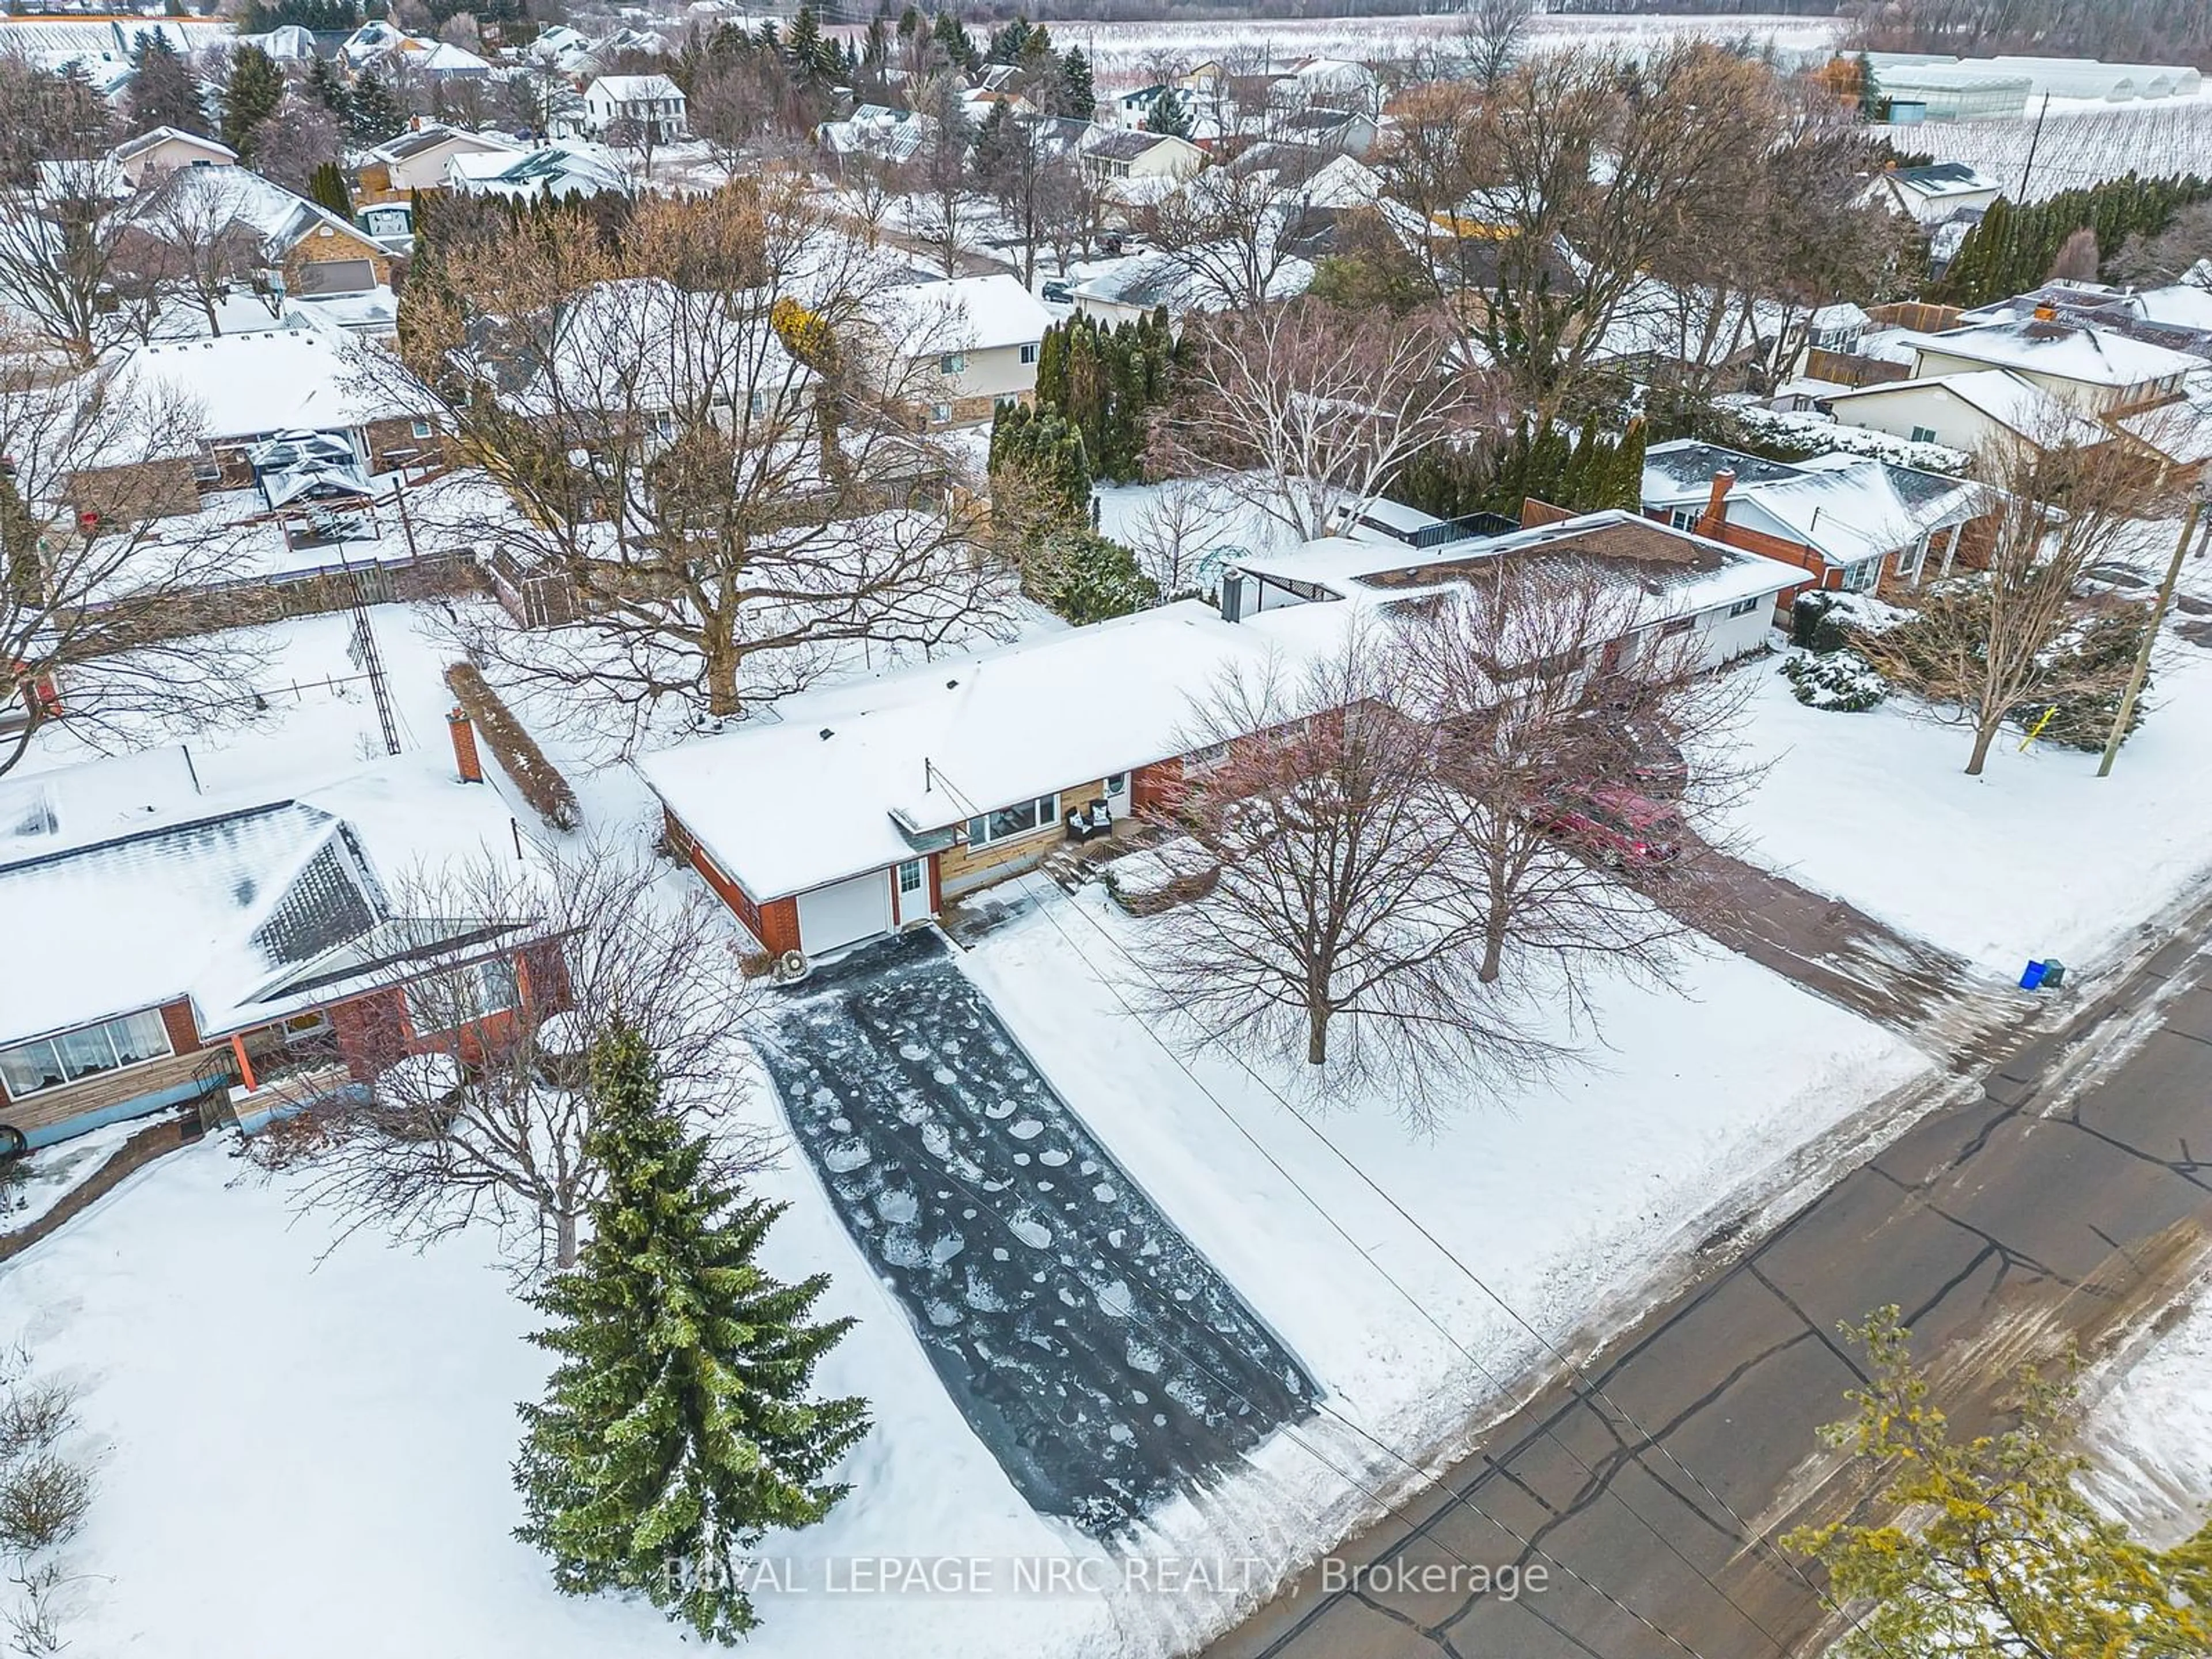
[{"x1": 0, "y1": 350, "x2": 263, "y2": 772}]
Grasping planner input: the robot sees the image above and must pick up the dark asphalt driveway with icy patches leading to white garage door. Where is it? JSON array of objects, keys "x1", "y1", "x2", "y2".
[{"x1": 763, "y1": 933, "x2": 1314, "y2": 1533}]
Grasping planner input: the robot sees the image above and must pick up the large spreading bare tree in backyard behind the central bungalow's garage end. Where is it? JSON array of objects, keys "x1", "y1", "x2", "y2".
[{"x1": 389, "y1": 181, "x2": 1009, "y2": 738}]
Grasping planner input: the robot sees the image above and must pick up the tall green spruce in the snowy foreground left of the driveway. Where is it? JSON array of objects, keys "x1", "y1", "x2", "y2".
[{"x1": 516, "y1": 1027, "x2": 867, "y2": 1643}]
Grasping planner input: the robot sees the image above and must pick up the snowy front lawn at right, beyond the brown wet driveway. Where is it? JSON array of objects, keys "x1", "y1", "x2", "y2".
[{"x1": 1736, "y1": 606, "x2": 2212, "y2": 975}]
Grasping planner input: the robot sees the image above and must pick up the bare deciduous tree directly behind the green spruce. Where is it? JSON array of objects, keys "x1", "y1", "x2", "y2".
[{"x1": 268, "y1": 843, "x2": 763, "y2": 1272}]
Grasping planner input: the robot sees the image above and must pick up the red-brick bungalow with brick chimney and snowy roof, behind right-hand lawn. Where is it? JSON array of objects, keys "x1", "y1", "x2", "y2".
[{"x1": 1643, "y1": 438, "x2": 1991, "y2": 604}]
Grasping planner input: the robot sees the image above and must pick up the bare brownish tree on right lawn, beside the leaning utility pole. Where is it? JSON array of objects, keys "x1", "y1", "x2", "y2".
[{"x1": 1858, "y1": 435, "x2": 2157, "y2": 777}]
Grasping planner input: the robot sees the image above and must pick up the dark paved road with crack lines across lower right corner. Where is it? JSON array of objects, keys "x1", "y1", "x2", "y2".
[{"x1": 1208, "y1": 916, "x2": 2212, "y2": 1659}]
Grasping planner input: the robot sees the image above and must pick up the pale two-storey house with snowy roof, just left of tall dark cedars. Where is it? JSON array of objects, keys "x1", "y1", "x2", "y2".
[{"x1": 882, "y1": 274, "x2": 1053, "y2": 427}]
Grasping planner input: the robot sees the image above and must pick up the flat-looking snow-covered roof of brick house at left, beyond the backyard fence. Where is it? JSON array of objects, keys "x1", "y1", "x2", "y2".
[{"x1": 118, "y1": 329, "x2": 429, "y2": 442}]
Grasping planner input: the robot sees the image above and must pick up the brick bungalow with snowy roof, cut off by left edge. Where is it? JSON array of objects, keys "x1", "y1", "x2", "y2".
[{"x1": 0, "y1": 748, "x2": 569, "y2": 1150}]
